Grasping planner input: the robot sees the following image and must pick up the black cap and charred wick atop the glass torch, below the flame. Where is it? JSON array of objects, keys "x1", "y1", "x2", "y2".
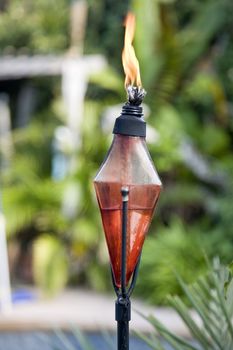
[{"x1": 113, "y1": 86, "x2": 146, "y2": 137}]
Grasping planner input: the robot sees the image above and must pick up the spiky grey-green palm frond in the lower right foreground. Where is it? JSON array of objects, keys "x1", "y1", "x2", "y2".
[{"x1": 138, "y1": 259, "x2": 233, "y2": 350}]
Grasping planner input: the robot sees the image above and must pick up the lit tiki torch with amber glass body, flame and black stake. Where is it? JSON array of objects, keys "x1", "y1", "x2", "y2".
[{"x1": 94, "y1": 13, "x2": 161, "y2": 350}]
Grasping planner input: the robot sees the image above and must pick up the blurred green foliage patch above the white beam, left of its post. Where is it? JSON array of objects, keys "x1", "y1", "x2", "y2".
[{"x1": 0, "y1": 0, "x2": 69, "y2": 54}]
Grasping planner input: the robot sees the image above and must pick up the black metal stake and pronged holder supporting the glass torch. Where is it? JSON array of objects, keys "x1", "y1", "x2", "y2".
[{"x1": 111, "y1": 187, "x2": 140, "y2": 350}]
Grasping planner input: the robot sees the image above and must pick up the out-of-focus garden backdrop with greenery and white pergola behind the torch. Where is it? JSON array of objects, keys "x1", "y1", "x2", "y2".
[{"x1": 0, "y1": 0, "x2": 233, "y2": 304}]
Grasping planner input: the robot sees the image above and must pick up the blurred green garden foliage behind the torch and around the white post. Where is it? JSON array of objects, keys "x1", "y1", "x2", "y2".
[{"x1": 0, "y1": 0, "x2": 233, "y2": 303}]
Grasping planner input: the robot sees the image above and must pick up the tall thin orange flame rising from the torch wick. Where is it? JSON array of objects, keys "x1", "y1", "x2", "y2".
[{"x1": 122, "y1": 12, "x2": 142, "y2": 87}]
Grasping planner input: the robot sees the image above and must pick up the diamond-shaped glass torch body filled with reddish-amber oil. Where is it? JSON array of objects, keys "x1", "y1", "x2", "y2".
[{"x1": 94, "y1": 134, "x2": 161, "y2": 288}]
